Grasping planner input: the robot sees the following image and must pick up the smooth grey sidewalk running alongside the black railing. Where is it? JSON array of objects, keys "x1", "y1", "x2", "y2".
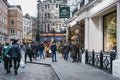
[{"x1": 34, "y1": 54, "x2": 120, "y2": 80}]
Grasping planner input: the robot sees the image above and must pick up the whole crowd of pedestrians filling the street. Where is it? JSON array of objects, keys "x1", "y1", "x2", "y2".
[{"x1": 0, "y1": 41, "x2": 83, "y2": 74}]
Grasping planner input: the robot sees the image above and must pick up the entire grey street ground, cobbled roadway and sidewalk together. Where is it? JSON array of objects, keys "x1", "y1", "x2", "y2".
[{"x1": 0, "y1": 49, "x2": 120, "y2": 80}]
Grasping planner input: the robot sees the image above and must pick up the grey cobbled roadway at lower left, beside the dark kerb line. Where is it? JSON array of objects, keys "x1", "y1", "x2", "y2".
[{"x1": 0, "y1": 63, "x2": 59, "y2": 80}]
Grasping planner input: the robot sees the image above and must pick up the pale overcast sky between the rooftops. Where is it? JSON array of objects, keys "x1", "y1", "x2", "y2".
[{"x1": 8, "y1": 0, "x2": 42, "y2": 17}]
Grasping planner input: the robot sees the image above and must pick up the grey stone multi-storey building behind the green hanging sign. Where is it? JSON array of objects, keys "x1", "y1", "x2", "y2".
[{"x1": 38, "y1": 0, "x2": 66, "y2": 40}]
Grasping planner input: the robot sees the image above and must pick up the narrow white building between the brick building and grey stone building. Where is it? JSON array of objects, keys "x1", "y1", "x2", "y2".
[{"x1": 23, "y1": 14, "x2": 32, "y2": 42}]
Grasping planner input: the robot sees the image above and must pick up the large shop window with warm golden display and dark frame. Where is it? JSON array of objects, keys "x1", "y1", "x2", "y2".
[{"x1": 103, "y1": 12, "x2": 117, "y2": 52}]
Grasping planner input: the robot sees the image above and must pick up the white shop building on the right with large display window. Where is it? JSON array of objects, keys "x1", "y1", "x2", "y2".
[{"x1": 66, "y1": 0, "x2": 120, "y2": 77}]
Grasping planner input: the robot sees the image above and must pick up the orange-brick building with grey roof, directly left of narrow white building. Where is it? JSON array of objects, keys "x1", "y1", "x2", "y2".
[{"x1": 8, "y1": 5, "x2": 23, "y2": 42}]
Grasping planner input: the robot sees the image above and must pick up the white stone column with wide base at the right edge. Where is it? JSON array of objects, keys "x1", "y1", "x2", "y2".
[{"x1": 112, "y1": 1, "x2": 120, "y2": 77}]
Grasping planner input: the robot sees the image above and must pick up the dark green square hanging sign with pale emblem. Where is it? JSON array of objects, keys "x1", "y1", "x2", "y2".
[{"x1": 59, "y1": 6, "x2": 70, "y2": 18}]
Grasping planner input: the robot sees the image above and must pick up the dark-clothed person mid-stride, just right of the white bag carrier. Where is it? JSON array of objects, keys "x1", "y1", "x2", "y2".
[{"x1": 25, "y1": 43, "x2": 32, "y2": 64}]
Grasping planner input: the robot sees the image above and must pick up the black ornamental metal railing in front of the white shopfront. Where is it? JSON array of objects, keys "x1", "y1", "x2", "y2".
[{"x1": 85, "y1": 50, "x2": 117, "y2": 73}]
